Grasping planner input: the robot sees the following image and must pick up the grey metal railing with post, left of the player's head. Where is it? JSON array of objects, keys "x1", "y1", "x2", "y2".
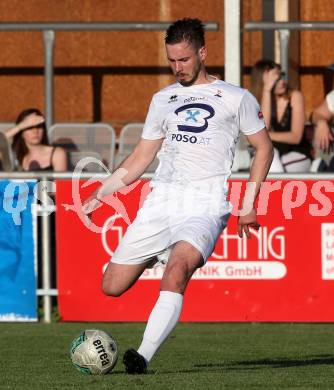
[{"x1": 0, "y1": 22, "x2": 219, "y2": 128}]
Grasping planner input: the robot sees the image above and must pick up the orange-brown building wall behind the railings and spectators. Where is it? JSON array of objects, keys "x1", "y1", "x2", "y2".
[{"x1": 0, "y1": 0, "x2": 334, "y2": 128}]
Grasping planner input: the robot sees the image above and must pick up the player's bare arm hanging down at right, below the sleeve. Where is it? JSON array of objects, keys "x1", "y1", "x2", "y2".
[{"x1": 238, "y1": 129, "x2": 274, "y2": 238}]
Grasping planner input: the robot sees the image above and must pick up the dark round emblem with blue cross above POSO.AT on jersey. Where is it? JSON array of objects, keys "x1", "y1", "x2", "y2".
[{"x1": 175, "y1": 103, "x2": 215, "y2": 133}]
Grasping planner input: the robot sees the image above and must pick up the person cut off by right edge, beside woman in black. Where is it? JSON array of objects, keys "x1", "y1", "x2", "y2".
[{"x1": 311, "y1": 89, "x2": 334, "y2": 172}]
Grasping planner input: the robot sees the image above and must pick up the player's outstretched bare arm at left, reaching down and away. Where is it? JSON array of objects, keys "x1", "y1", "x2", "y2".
[{"x1": 82, "y1": 138, "x2": 163, "y2": 214}]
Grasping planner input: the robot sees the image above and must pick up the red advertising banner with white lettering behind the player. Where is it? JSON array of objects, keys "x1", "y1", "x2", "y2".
[{"x1": 56, "y1": 180, "x2": 334, "y2": 322}]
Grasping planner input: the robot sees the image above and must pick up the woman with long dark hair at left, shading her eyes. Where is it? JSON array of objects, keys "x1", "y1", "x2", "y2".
[{"x1": 6, "y1": 108, "x2": 67, "y2": 171}]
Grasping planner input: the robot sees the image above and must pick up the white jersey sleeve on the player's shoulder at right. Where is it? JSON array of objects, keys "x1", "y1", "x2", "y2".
[{"x1": 238, "y1": 91, "x2": 266, "y2": 135}]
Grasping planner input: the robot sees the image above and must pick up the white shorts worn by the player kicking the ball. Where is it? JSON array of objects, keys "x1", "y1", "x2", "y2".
[{"x1": 110, "y1": 184, "x2": 231, "y2": 266}]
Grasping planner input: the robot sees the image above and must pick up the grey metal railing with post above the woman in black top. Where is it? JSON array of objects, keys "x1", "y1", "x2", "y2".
[{"x1": 243, "y1": 22, "x2": 334, "y2": 81}]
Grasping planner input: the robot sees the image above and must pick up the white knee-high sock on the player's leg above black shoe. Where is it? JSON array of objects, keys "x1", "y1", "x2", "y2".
[{"x1": 138, "y1": 291, "x2": 183, "y2": 362}]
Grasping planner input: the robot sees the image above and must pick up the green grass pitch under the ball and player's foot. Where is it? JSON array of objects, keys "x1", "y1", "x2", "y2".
[{"x1": 0, "y1": 323, "x2": 334, "y2": 390}]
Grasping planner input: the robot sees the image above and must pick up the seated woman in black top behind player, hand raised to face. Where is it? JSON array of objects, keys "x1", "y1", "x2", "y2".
[{"x1": 251, "y1": 60, "x2": 312, "y2": 173}]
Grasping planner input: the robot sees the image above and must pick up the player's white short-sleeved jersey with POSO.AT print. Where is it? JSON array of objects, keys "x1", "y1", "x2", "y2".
[{"x1": 142, "y1": 80, "x2": 265, "y2": 193}]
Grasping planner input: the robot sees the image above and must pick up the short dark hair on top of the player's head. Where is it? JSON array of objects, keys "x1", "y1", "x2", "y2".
[{"x1": 165, "y1": 18, "x2": 205, "y2": 49}]
